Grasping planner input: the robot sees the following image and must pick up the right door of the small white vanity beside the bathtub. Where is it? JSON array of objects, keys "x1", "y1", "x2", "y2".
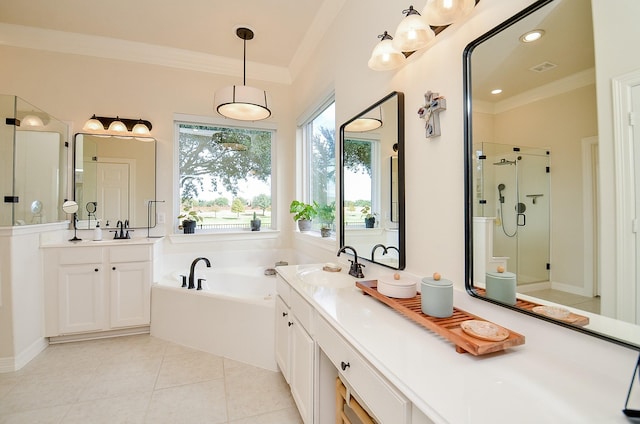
[{"x1": 110, "y1": 262, "x2": 151, "y2": 328}]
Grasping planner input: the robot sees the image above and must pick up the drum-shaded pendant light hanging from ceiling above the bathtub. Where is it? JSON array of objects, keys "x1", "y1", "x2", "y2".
[{"x1": 213, "y1": 27, "x2": 271, "y2": 121}]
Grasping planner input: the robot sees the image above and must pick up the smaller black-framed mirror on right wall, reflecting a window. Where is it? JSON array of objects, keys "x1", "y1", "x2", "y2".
[{"x1": 340, "y1": 91, "x2": 406, "y2": 269}]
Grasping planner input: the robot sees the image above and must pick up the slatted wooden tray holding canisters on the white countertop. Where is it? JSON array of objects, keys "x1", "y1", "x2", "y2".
[{"x1": 356, "y1": 280, "x2": 524, "y2": 356}]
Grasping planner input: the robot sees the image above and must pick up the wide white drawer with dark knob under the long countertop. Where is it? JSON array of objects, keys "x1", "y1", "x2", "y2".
[{"x1": 316, "y1": 319, "x2": 411, "y2": 424}]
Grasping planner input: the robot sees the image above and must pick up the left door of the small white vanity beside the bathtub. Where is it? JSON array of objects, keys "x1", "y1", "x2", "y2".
[{"x1": 58, "y1": 264, "x2": 105, "y2": 334}]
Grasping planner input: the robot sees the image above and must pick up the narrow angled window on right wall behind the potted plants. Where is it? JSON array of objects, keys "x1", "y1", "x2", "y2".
[{"x1": 303, "y1": 100, "x2": 336, "y2": 231}]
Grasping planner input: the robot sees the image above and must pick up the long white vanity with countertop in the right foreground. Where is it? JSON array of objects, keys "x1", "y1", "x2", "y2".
[{"x1": 276, "y1": 264, "x2": 634, "y2": 424}]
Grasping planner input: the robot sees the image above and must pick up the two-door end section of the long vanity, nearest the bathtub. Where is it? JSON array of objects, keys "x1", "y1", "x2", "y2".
[{"x1": 276, "y1": 276, "x2": 316, "y2": 424}]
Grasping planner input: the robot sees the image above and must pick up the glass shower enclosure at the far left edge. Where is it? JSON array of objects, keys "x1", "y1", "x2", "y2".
[{"x1": 0, "y1": 95, "x2": 69, "y2": 227}]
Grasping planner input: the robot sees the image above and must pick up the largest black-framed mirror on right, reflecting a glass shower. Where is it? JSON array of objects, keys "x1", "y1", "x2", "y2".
[{"x1": 463, "y1": 0, "x2": 640, "y2": 349}]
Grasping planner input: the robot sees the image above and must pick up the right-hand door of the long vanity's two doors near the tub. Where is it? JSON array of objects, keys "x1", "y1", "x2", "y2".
[{"x1": 290, "y1": 317, "x2": 314, "y2": 424}]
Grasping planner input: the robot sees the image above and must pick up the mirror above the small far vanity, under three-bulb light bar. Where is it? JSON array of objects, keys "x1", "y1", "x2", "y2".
[{"x1": 73, "y1": 134, "x2": 156, "y2": 228}]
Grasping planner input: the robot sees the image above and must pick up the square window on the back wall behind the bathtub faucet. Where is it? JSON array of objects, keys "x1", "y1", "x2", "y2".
[{"x1": 176, "y1": 122, "x2": 275, "y2": 230}]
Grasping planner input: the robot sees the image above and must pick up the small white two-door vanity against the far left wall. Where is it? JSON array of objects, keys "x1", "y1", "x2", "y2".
[{"x1": 42, "y1": 239, "x2": 160, "y2": 342}]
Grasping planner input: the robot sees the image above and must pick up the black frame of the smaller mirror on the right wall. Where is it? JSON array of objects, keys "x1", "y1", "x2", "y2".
[{"x1": 339, "y1": 91, "x2": 406, "y2": 270}]
